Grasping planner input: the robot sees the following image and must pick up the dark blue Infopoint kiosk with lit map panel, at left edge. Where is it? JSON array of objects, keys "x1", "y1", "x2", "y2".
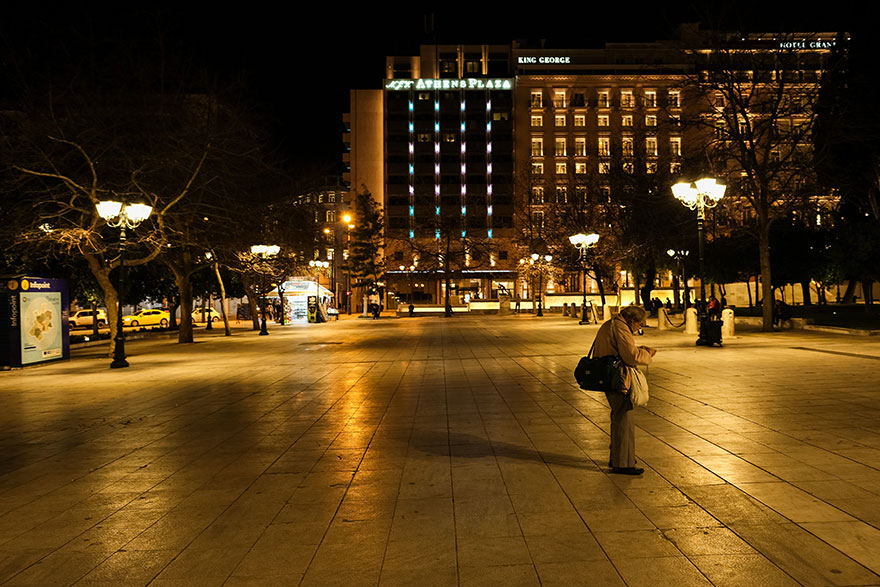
[{"x1": 0, "y1": 277, "x2": 70, "y2": 367}]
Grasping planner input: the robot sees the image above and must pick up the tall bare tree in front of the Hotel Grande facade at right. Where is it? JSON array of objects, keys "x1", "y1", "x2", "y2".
[{"x1": 685, "y1": 33, "x2": 833, "y2": 330}]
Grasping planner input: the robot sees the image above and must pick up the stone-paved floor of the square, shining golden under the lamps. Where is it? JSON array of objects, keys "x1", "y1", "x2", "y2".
[{"x1": 0, "y1": 316, "x2": 880, "y2": 586}]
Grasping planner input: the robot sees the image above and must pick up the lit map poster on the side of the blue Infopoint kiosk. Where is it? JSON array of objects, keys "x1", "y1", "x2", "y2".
[{"x1": 19, "y1": 291, "x2": 64, "y2": 365}]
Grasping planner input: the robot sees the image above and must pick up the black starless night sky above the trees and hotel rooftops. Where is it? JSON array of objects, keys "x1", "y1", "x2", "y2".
[{"x1": 0, "y1": 1, "x2": 860, "y2": 175}]
